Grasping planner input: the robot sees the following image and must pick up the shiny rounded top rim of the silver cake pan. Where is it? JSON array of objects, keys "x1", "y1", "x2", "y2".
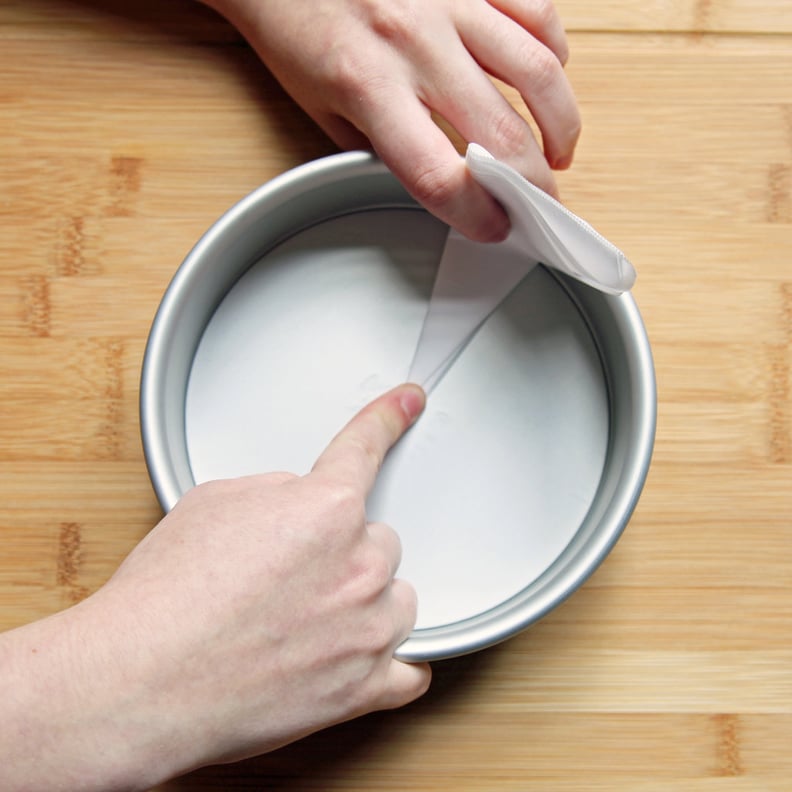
[{"x1": 140, "y1": 152, "x2": 656, "y2": 661}]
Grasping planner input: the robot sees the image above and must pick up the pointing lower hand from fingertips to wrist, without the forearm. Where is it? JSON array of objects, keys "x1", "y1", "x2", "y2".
[{"x1": 100, "y1": 385, "x2": 431, "y2": 771}]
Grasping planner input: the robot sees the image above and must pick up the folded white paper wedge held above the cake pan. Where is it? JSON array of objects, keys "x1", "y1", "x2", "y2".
[{"x1": 407, "y1": 144, "x2": 635, "y2": 392}]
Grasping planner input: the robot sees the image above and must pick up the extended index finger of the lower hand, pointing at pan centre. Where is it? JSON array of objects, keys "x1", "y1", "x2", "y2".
[{"x1": 313, "y1": 383, "x2": 426, "y2": 494}]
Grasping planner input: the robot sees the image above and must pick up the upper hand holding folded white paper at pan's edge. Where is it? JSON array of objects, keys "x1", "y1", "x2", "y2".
[{"x1": 204, "y1": 0, "x2": 580, "y2": 242}]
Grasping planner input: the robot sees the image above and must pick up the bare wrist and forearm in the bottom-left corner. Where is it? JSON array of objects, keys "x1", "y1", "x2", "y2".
[{"x1": 0, "y1": 593, "x2": 187, "y2": 792}]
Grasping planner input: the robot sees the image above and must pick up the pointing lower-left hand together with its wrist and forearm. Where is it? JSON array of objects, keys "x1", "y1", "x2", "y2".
[{"x1": 0, "y1": 385, "x2": 431, "y2": 790}]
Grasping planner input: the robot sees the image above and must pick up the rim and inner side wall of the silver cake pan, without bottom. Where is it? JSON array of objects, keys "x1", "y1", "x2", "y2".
[{"x1": 140, "y1": 152, "x2": 656, "y2": 661}]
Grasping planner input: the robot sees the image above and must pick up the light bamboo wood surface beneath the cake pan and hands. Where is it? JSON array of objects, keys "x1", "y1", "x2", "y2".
[{"x1": 0, "y1": 0, "x2": 792, "y2": 792}]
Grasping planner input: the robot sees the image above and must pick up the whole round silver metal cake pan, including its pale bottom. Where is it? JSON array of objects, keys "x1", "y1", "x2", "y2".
[{"x1": 141, "y1": 154, "x2": 655, "y2": 660}]
